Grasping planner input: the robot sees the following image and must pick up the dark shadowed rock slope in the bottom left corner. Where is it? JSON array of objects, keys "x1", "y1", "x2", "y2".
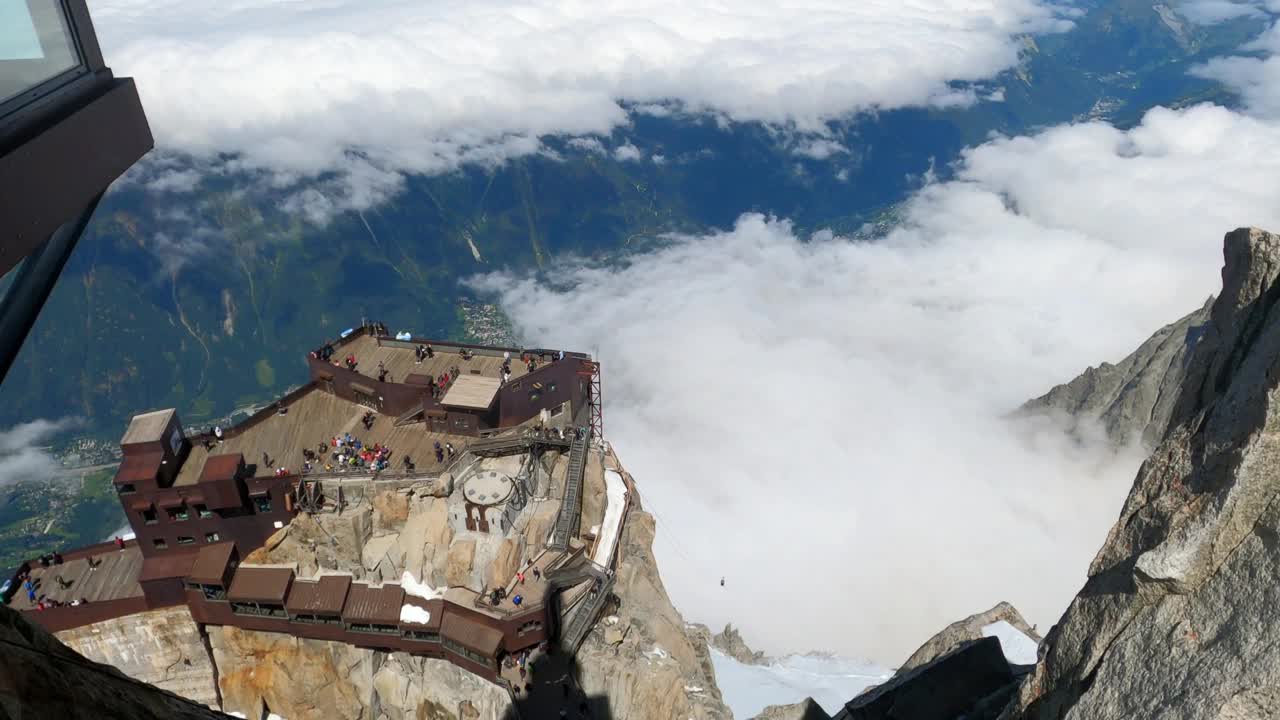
[{"x1": 0, "y1": 606, "x2": 228, "y2": 720}]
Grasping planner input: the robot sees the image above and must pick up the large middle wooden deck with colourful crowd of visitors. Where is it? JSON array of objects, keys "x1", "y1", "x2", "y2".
[{"x1": 174, "y1": 384, "x2": 475, "y2": 486}]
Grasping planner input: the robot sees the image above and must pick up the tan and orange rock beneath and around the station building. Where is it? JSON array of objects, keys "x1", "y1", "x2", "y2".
[{"x1": 209, "y1": 445, "x2": 731, "y2": 720}]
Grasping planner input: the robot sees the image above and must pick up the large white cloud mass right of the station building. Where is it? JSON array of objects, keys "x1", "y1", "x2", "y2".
[{"x1": 477, "y1": 106, "x2": 1280, "y2": 665}]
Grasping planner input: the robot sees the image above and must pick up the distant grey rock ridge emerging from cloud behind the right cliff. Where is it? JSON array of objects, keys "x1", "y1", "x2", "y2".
[{"x1": 1019, "y1": 297, "x2": 1213, "y2": 451}]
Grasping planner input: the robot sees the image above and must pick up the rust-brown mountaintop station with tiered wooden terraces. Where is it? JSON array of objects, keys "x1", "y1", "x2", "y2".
[{"x1": 0, "y1": 323, "x2": 620, "y2": 682}]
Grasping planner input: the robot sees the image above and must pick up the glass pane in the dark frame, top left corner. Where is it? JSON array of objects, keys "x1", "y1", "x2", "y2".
[{"x1": 0, "y1": 0, "x2": 81, "y2": 102}]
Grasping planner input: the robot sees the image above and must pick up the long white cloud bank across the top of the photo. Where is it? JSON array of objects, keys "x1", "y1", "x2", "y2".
[{"x1": 93, "y1": 0, "x2": 1071, "y2": 211}]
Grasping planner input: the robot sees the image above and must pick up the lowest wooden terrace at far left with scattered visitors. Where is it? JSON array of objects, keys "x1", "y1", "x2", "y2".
[{"x1": 9, "y1": 546, "x2": 142, "y2": 610}]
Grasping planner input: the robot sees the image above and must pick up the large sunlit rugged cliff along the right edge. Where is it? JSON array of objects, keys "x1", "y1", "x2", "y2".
[{"x1": 1002, "y1": 229, "x2": 1280, "y2": 720}]
